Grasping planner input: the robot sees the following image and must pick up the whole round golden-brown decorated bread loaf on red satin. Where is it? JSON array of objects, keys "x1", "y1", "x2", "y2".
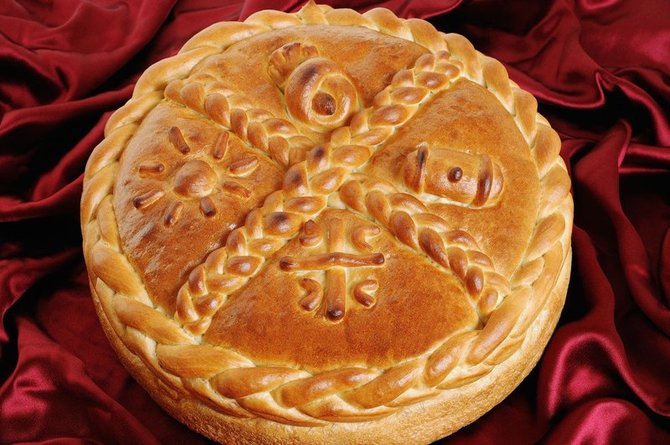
[{"x1": 81, "y1": 3, "x2": 572, "y2": 443}]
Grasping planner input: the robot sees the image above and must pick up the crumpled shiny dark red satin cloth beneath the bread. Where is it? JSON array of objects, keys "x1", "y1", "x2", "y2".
[{"x1": 0, "y1": 0, "x2": 670, "y2": 445}]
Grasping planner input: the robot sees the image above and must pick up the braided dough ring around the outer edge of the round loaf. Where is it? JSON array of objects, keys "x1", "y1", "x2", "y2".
[{"x1": 82, "y1": 2, "x2": 572, "y2": 425}]
